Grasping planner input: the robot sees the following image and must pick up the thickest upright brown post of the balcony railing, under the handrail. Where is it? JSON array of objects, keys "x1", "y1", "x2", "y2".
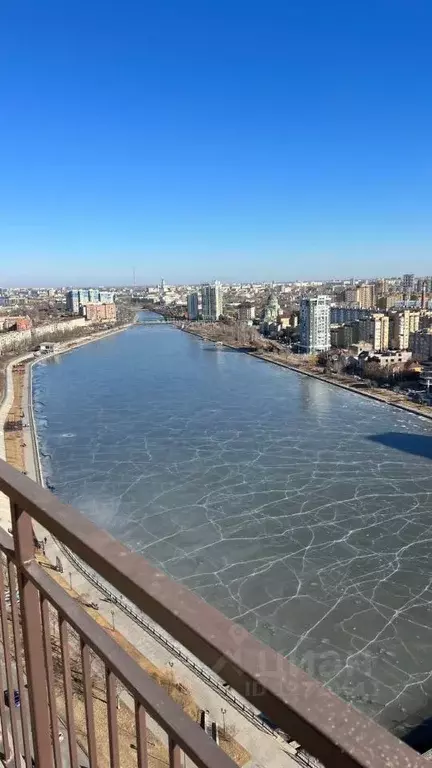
[{"x1": 11, "y1": 502, "x2": 53, "y2": 768}]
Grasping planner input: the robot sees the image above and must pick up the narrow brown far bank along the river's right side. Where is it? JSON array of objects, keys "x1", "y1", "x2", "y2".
[{"x1": 185, "y1": 327, "x2": 432, "y2": 420}]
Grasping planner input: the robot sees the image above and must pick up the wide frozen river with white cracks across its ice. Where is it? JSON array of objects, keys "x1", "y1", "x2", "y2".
[{"x1": 33, "y1": 318, "x2": 432, "y2": 732}]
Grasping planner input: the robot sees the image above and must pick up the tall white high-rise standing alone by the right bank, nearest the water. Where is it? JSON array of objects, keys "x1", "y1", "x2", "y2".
[{"x1": 300, "y1": 294, "x2": 331, "y2": 355}]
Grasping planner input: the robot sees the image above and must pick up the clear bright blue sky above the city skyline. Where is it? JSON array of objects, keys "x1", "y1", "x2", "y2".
[{"x1": 0, "y1": 0, "x2": 432, "y2": 285}]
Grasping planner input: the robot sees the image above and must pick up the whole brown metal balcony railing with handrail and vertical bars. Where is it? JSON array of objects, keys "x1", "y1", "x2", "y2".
[{"x1": 0, "y1": 461, "x2": 428, "y2": 768}]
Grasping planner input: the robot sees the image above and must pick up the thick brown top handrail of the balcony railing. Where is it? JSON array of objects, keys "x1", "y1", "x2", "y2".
[{"x1": 0, "y1": 460, "x2": 427, "y2": 768}]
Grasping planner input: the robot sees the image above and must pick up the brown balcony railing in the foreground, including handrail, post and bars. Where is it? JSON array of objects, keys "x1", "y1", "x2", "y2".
[{"x1": 0, "y1": 452, "x2": 426, "y2": 768}]
